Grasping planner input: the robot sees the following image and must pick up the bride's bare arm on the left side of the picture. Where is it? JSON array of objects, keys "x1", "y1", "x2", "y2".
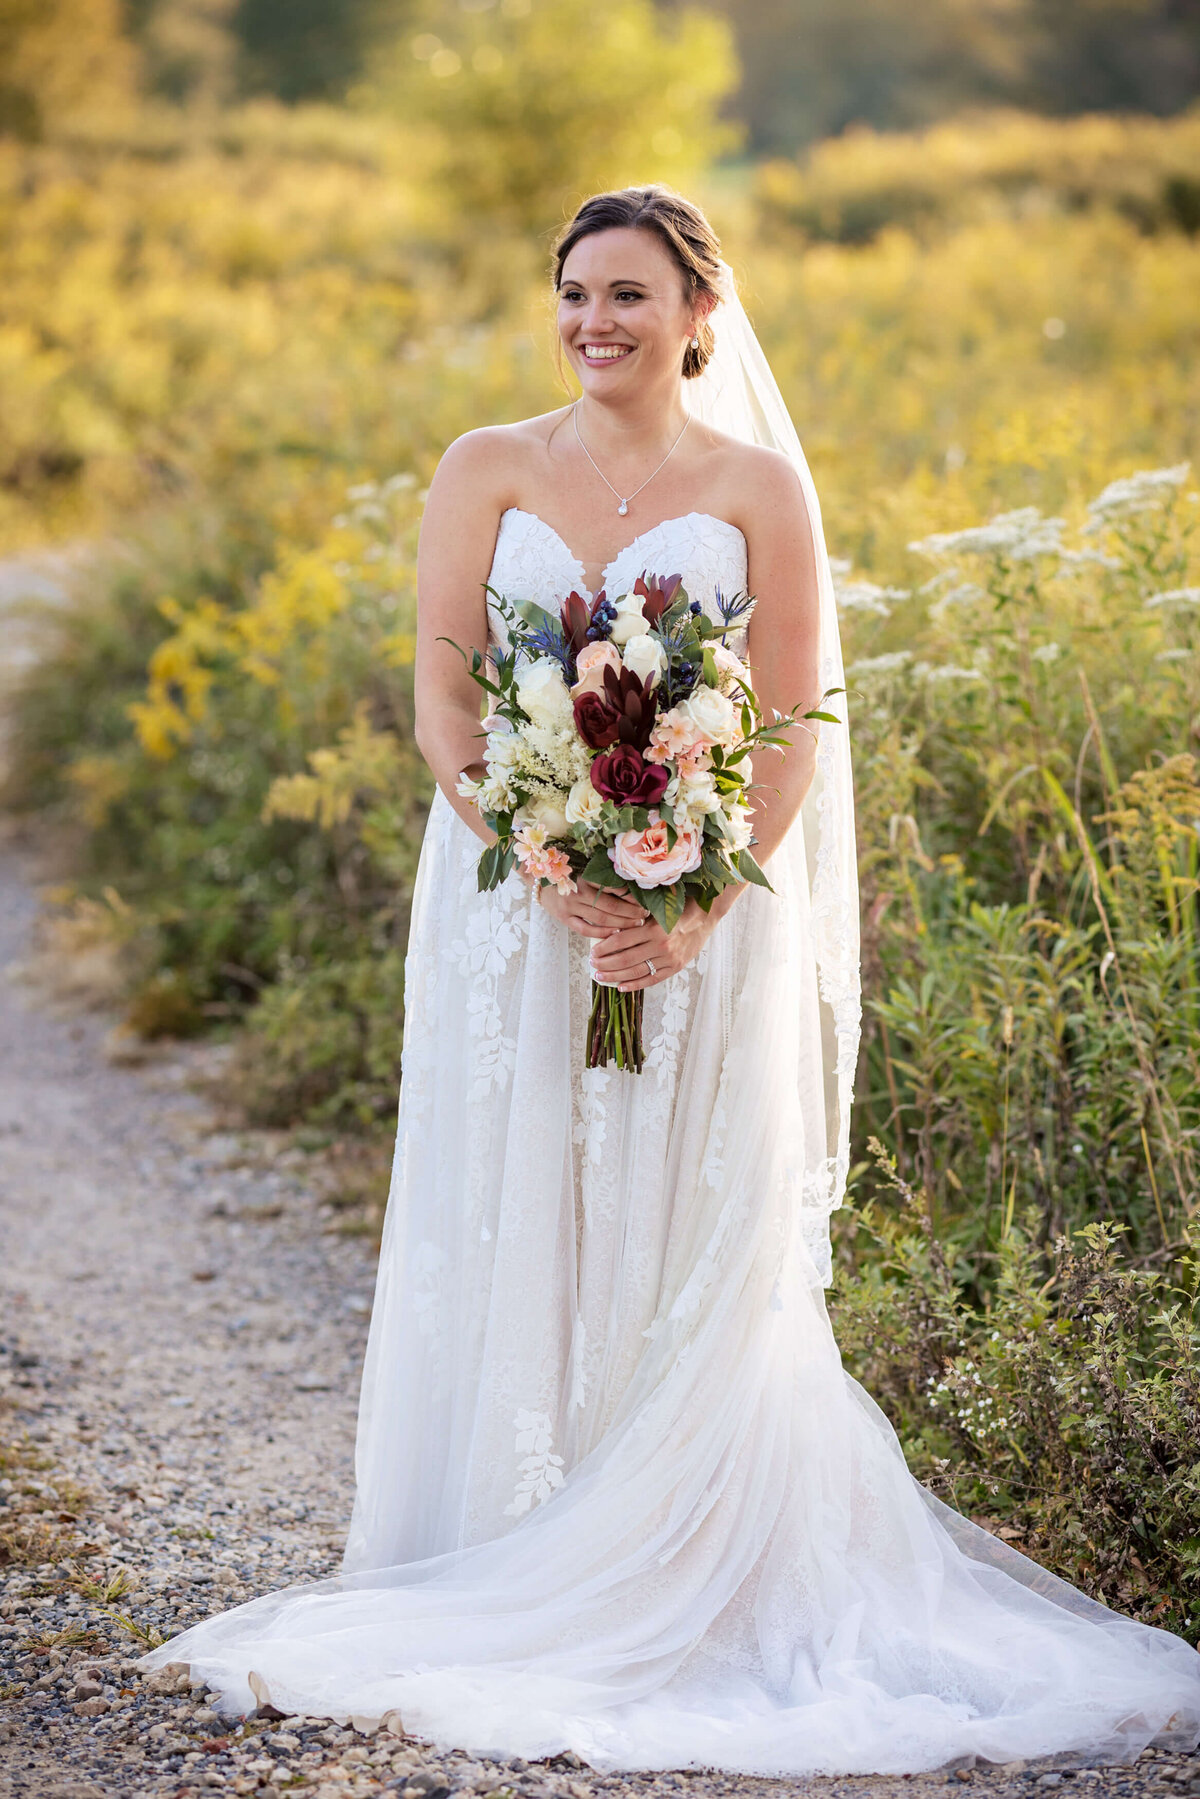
[{"x1": 414, "y1": 428, "x2": 506, "y2": 844}]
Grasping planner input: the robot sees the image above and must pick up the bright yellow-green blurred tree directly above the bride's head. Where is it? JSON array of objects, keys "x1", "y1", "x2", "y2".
[{"x1": 353, "y1": 0, "x2": 739, "y2": 232}]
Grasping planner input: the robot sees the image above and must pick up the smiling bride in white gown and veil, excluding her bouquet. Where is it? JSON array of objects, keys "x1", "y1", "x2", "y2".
[{"x1": 142, "y1": 187, "x2": 1200, "y2": 1776}]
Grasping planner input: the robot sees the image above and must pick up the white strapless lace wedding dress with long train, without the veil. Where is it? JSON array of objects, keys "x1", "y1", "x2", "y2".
[{"x1": 144, "y1": 511, "x2": 1200, "y2": 1776}]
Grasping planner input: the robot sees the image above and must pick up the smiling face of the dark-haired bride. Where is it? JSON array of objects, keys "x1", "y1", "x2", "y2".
[{"x1": 558, "y1": 227, "x2": 700, "y2": 399}]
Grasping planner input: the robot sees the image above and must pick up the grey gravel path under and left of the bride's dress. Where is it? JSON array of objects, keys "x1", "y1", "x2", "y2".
[{"x1": 0, "y1": 840, "x2": 1200, "y2": 1799}]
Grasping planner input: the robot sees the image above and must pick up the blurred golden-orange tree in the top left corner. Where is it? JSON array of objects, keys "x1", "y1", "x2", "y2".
[{"x1": 0, "y1": 0, "x2": 139, "y2": 140}]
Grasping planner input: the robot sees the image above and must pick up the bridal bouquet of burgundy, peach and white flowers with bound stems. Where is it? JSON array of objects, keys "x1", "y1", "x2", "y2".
[{"x1": 441, "y1": 572, "x2": 842, "y2": 1072}]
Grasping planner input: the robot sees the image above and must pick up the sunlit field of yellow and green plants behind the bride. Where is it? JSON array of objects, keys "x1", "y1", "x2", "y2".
[{"x1": 0, "y1": 5, "x2": 1200, "y2": 1635}]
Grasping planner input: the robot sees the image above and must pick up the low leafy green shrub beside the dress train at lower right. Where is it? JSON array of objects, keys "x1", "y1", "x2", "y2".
[{"x1": 833, "y1": 1144, "x2": 1200, "y2": 1642}]
